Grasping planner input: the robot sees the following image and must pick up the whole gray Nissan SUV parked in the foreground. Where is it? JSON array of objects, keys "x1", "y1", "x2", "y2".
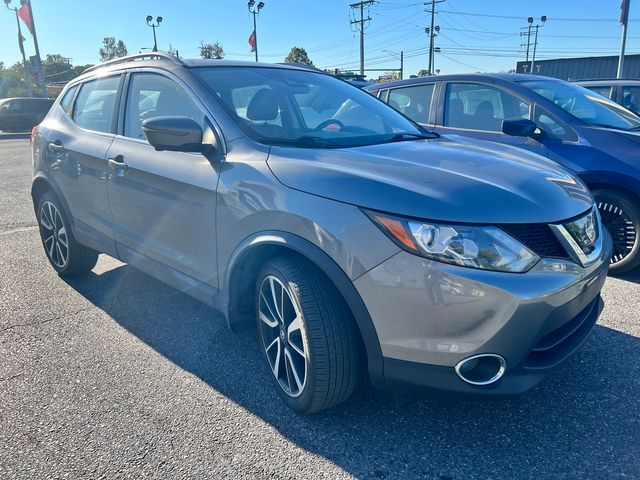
[{"x1": 32, "y1": 54, "x2": 611, "y2": 413}]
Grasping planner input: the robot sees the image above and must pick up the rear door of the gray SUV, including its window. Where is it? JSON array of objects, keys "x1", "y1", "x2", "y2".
[{"x1": 45, "y1": 74, "x2": 122, "y2": 254}]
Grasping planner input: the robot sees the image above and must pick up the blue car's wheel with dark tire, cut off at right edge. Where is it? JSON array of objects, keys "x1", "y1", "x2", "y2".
[{"x1": 593, "y1": 190, "x2": 640, "y2": 275}]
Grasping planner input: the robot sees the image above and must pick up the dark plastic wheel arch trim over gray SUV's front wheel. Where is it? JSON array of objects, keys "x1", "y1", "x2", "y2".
[{"x1": 220, "y1": 230, "x2": 385, "y2": 388}]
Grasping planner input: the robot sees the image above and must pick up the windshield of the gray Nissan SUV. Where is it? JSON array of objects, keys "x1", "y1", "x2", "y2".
[{"x1": 195, "y1": 67, "x2": 428, "y2": 148}]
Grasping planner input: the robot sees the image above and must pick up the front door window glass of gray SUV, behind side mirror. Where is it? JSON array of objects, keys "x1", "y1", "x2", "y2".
[{"x1": 124, "y1": 73, "x2": 205, "y2": 139}]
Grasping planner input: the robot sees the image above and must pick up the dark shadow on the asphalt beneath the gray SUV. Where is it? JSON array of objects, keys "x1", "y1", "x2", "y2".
[{"x1": 66, "y1": 266, "x2": 640, "y2": 479}]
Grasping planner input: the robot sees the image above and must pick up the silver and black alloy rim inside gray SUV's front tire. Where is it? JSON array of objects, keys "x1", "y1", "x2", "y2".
[{"x1": 258, "y1": 275, "x2": 308, "y2": 397}]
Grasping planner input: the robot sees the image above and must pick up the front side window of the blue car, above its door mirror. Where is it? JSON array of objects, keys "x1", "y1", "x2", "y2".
[{"x1": 444, "y1": 83, "x2": 531, "y2": 132}]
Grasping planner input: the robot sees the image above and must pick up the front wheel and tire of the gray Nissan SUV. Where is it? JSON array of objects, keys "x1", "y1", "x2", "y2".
[{"x1": 255, "y1": 255, "x2": 360, "y2": 414}]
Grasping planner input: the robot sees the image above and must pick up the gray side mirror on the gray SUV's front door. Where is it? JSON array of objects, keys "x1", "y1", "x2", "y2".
[{"x1": 142, "y1": 117, "x2": 212, "y2": 153}]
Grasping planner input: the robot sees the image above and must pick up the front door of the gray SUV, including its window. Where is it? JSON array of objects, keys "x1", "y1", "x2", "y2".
[{"x1": 109, "y1": 71, "x2": 220, "y2": 288}]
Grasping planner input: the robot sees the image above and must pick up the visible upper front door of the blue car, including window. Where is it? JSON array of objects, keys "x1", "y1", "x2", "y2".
[{"x1": 435, "y1": 82, "x2": 548, "y2": 156}]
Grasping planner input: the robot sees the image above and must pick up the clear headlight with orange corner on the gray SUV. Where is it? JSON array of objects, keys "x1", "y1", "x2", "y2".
[{"x1": 365, "y1": 211, "x2": 540, "y2": 273}]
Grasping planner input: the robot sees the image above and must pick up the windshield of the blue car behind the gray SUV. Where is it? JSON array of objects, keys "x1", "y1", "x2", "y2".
[{"x1": 522, "y1": 80, "x2": 640, "y2": 130}]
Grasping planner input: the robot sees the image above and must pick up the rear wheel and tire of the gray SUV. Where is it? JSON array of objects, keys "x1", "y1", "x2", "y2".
[{"x1": 36, "y1": 192, "x2": 98, "y2": 276}]
